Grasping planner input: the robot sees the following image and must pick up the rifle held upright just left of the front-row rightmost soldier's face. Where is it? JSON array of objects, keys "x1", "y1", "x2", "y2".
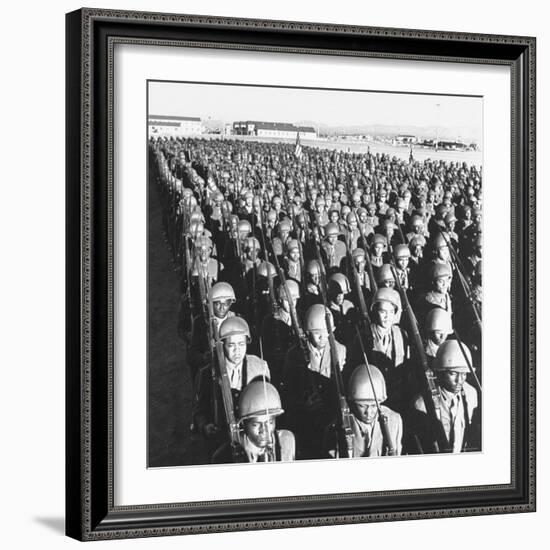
[{"x1": 390, "y1": 257, "x2": 452, "y2": 453}]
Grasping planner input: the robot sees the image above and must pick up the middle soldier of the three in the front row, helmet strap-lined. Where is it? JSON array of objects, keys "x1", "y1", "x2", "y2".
[{"x1": 326, "y1": 364, "x2": 403, "y2": 458}]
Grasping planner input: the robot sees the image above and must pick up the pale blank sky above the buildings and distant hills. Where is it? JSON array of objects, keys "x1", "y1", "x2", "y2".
[{"x1": 149, "y1": 82, "x2": 483, "y2": 141}]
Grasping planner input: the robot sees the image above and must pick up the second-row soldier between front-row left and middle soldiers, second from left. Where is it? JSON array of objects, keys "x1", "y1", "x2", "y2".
[{"x1": 284, "y1": 304, "x2": 346, "y2": 458}]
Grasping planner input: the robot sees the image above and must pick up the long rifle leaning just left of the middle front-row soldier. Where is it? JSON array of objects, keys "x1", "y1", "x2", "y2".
[{"x1": 313, "y1": 218, "x2": 354, "y2": 458}]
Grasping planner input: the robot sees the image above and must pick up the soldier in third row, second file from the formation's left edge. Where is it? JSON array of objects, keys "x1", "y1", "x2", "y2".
[{"x1": 261, "y1": 279, "x2": 300, "y2": 387}]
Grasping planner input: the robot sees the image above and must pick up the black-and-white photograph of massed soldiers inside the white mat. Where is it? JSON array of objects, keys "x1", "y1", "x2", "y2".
[{"x1": 146, "y1": 80, "x2": 490, "y2": 468}]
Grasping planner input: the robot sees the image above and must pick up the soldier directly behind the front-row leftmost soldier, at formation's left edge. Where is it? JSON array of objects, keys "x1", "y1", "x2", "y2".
[{"x1": 193, "y1": 316, "x2": 270, "y2": 451}]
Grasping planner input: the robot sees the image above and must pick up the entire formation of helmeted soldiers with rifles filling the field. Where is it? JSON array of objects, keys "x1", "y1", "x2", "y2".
[{"x1": 149, "y1": 138, "x2": 482, "y2": 462}]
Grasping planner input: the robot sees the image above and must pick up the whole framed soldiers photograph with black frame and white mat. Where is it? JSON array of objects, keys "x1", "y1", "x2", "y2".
[{"x1": 66, "y1": 9, "x2": 536, "y2": 540}]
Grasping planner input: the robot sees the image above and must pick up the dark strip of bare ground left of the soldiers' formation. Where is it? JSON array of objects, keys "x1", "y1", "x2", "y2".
[{"x1": 147, "y1": 176, "x2": 206, "y2": 467}]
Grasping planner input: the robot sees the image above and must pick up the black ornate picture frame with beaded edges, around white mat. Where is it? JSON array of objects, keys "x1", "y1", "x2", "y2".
[{"x1": 66, "y1": 9, "x2": 536, "y2": 540}]
